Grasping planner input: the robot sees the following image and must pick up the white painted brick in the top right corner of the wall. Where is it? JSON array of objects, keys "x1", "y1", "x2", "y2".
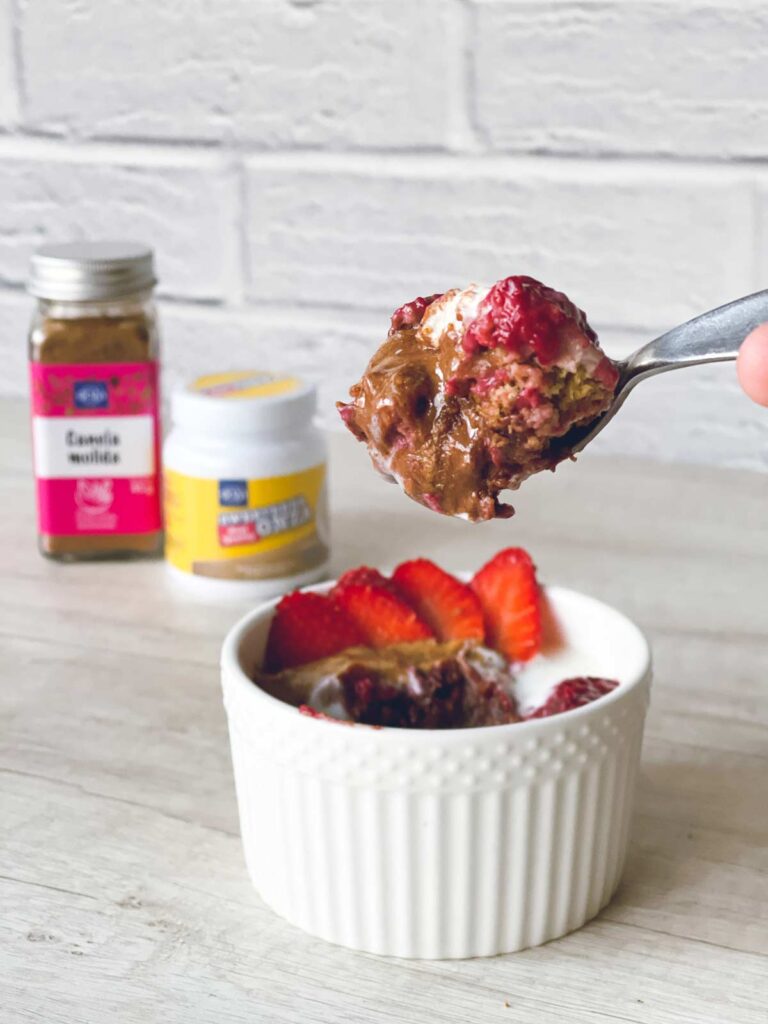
[{"x1": 475, "y1": 0, "x2": 768, "y2": 160}]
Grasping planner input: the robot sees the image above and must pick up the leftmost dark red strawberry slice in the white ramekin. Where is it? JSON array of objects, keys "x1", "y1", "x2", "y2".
[{"x1": 264, "y1": 590, "x2": 366, "y2": 672}]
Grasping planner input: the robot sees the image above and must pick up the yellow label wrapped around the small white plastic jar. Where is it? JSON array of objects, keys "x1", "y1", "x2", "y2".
[{"x1": 165, "y1": 465, "x2": 329, "y2": 580}]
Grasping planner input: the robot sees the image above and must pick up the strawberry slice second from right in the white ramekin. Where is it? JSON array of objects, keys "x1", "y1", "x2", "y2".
[{"x1": 392, "y1": 558, "x2": 485, "y2": 640}]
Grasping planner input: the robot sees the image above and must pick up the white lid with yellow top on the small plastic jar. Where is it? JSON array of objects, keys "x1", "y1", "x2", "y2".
[{"x1": 171, "y1": 370, "x2": 317, "y2": 437}]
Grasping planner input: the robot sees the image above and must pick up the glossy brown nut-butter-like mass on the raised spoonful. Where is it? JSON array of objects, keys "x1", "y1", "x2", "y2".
[{"x1": 337, "y1": 326, "x2": 611, "y2": 521}]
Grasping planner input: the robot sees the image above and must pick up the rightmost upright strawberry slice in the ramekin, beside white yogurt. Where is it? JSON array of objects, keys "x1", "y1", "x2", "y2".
[{"x1": 470, "y1": 548, "x2": 542, "y2": 662}]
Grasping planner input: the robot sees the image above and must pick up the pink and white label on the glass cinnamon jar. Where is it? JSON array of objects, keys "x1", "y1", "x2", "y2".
[{"x1": 30, "y1": 362, "x2": 161, "y2": 536}]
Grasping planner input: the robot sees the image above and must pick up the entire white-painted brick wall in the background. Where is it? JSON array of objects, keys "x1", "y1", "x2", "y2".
[{"x1": 0, "y1": 0, "x2": 768, "y2": 469}]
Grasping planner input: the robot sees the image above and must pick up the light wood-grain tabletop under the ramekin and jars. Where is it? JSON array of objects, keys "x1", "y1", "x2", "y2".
[{"x1": 0, "y1": 401, "x2": 768, "y2": 1024}]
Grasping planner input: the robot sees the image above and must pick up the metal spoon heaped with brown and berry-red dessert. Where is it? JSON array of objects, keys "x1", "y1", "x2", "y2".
[{"x1": 338, "y1": 275, "x2": 768, "y2": 522}]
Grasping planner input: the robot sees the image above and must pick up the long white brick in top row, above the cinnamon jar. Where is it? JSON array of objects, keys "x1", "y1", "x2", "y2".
[{"x1": 20, "y1": 0, "x2": 453, "y2": 147}]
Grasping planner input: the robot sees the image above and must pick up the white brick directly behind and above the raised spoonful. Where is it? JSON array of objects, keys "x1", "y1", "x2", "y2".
[{"x1": 246, "y1": 155, "x2": 757, "y2": 327}]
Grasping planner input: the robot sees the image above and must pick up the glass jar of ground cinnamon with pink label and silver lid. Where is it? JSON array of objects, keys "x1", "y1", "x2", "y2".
[{"x1": 29, "y1": 242, "x2": 162, "y2": 560}]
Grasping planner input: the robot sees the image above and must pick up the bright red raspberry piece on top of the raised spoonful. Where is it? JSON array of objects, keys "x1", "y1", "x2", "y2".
[{"x1": 463, "y1": 276, "x2": 597, "y2": 366}]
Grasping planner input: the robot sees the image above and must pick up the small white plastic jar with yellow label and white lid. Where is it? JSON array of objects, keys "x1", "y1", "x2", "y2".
[{"x1": 163, "y1": 371, "x2": 329, "y2": 598}]
